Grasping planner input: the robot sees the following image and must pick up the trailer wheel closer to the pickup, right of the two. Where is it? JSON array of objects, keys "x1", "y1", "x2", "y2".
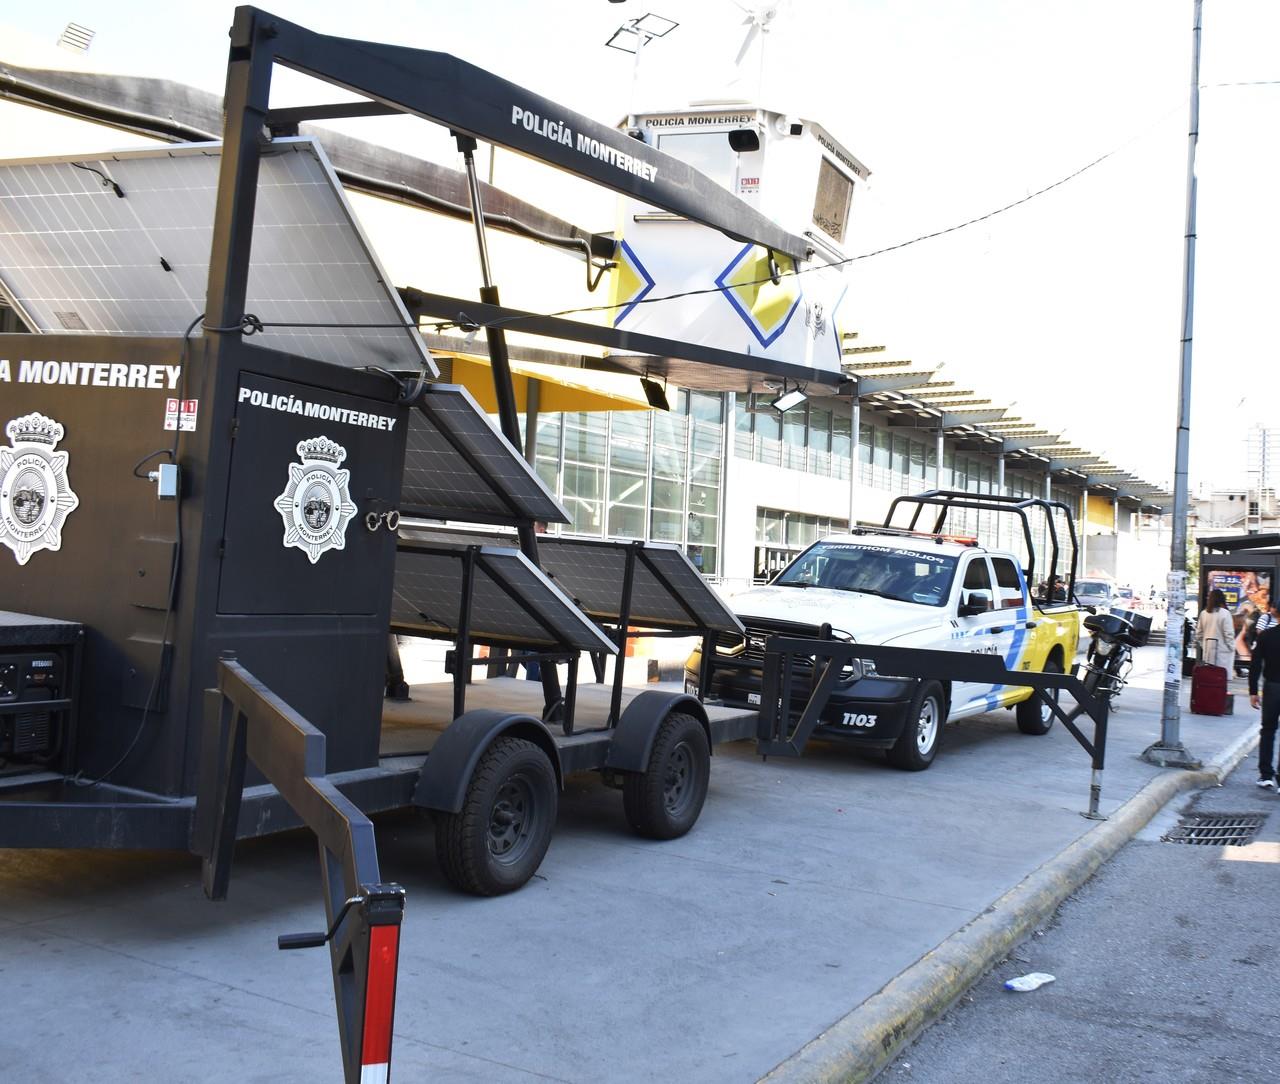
[{"x1": 622, "y1": 712, "x2": 712, "y2": 840}]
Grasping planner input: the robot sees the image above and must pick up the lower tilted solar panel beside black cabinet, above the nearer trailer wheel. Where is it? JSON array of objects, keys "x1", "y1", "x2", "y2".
[{"x1": 392, "y1": 543, "x2": 617, "y2": 654}]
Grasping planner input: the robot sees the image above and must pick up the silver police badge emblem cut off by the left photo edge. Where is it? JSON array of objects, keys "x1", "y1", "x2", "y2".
[{"x1": 0, "y1": 413, "x2": 79, "y2": 564}]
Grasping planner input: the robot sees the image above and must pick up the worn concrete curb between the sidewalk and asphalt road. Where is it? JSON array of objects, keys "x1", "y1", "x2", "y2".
[{"x1": 760, "y1": 726, "x2": 1258, "y2": 1084}]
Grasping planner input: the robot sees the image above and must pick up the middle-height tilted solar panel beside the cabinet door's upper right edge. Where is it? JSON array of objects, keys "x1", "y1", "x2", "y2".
[{"x1": 401, "y1": 384, "x2": 568, "y2": 523}]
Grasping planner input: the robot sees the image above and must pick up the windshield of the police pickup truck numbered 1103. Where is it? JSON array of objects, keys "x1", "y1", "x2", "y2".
[{"x1": 773, "y1": 543, "x2": 956, "y2": 607}]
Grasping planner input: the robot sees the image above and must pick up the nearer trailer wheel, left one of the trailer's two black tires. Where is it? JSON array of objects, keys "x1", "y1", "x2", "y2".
[{"x1": 435, "y1": 737, "x2": 557, "y2": 896}]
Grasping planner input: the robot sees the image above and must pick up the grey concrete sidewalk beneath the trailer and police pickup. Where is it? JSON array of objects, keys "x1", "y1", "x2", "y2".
[{"x1": 0, "y1": 648, "x2": 1257, "y2": 1081}]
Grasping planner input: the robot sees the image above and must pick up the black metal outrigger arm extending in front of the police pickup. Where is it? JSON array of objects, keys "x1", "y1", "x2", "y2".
[{"x1": 758, "y1": 636, "x2": 1108, "y2": 819}]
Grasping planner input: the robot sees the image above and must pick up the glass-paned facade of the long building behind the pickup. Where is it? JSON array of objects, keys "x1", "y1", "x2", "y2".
[{"x1": 536, "y1": 389, "x2": 1079, "y2": 578}]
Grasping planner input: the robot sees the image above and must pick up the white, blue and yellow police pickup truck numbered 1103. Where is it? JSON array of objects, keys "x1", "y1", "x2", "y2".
[{"x1": 685, "y1": 529, "x2": 1079, "y2": 772}]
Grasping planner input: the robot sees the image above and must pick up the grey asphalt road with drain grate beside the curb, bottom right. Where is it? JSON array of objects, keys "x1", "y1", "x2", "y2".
[{"x1": 879, "y1": 756, "x2": 1280, "y2": 1084}]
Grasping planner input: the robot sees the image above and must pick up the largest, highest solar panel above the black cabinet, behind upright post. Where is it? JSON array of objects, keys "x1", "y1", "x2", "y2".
[{"x1": 0, "y1": 138, "x2": 436, "y2": 375}]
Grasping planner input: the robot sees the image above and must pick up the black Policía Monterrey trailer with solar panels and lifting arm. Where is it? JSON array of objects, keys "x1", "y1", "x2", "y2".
[{"x1": 0, "y1": 8, "x2": 824, "y2": 1080}]
